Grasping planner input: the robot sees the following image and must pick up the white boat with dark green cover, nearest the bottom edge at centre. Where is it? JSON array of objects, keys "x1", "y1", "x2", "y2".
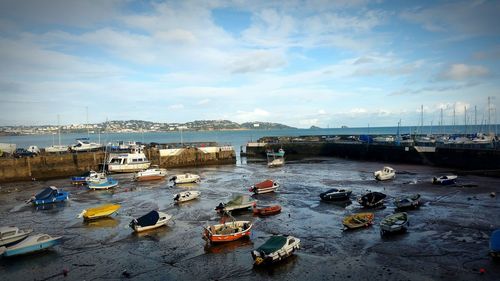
[{"x1": 252, "y1": 235, "x2": 300, "y2": 265}]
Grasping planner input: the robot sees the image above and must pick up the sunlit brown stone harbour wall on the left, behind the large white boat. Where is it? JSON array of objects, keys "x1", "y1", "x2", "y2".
[{"x1": 0, "y1": 147, "x2": 236, "y2": 182}]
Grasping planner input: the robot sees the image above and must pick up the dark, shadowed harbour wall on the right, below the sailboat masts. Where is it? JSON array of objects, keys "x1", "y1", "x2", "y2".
[{"x1": 246, "y1": 142, "x2": 500, "y2": 171}]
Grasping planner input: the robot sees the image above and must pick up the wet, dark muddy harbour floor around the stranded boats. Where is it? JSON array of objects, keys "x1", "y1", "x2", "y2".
[{"x1": 0, "y1": 158, "x2": 500, "y2": 280}]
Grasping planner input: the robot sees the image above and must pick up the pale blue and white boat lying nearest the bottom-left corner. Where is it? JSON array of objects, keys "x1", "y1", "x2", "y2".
[{"x1": 3, "y1": 234, "x2": 62, "y2": 257}]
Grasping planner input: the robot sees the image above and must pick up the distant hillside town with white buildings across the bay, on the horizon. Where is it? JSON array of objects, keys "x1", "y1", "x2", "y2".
[{"x1": 0, "y1": 120, "x2": 296, "y2": 135}]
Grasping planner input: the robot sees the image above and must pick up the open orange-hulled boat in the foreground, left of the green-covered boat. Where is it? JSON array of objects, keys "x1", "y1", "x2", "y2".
[{"x1": 203, "y1": 221, "x2": 252, "y2": 243}]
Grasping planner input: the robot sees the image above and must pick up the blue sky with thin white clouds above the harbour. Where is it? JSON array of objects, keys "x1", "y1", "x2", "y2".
[{"x1": 0, "y1": 0, "x2": 500, "y2": 128}]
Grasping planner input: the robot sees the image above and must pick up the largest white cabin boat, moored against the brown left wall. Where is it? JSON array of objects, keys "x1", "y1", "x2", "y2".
[{"x1": 107, "y1": 147, "x2": 151, "y2": 173}]
